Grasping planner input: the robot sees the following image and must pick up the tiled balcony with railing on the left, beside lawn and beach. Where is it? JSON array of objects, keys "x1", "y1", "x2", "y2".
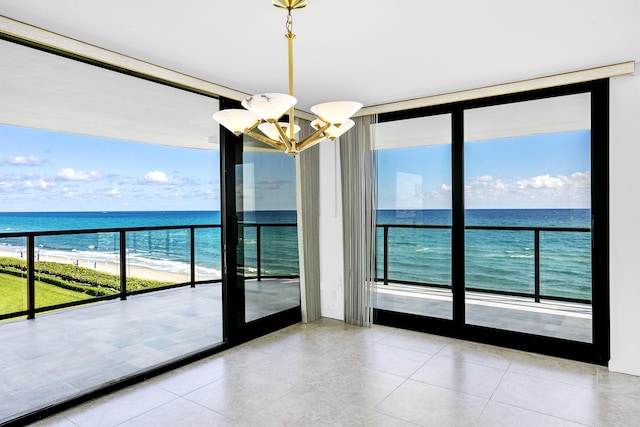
[{"x1": 0, "y1": 224, "x2": 300, "y2": 424}]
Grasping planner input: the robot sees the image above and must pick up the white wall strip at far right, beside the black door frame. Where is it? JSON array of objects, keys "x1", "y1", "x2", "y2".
[{"x1": 609, "y1": 72, "x2": 640, "y2": 375}]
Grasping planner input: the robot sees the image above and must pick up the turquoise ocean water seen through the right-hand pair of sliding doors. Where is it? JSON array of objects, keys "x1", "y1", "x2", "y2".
[{"x1": 377, "y1": 209, "x2": 591, "y2": 299}]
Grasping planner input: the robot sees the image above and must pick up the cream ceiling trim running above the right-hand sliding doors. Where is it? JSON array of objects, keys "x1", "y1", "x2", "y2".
[{"x1": 356, "y1": 61, "x2": 635, "y2": 116}]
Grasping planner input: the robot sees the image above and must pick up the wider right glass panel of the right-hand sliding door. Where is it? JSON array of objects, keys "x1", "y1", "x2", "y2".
[{"x1": 464, "y1": 93, "x2": 592, "y2": 343}]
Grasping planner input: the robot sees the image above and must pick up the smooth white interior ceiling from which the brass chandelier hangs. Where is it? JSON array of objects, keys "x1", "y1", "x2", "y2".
[{"x1": 0, "y1": 0, "x2": 640, "y2": 147}]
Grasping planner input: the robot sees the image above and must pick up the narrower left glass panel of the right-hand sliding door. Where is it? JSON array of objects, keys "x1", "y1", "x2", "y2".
[{"x1": 374, "y1": 114, "x2": 453, "y2": 319}]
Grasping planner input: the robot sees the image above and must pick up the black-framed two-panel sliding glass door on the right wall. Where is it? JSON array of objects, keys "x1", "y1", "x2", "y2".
[{"x1": 374, "y1": 80, "x2": 609, "y2": 363}]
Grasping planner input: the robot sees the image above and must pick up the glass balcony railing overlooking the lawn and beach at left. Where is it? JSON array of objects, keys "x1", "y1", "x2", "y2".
[{"x1": 0, "y1": 225, "x2": 222, "y2": 320}]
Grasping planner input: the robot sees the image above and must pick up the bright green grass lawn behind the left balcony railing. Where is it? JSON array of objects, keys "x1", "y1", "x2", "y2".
[{"x1": 0, "y1": 273, "x2": 92, "y2": 314}]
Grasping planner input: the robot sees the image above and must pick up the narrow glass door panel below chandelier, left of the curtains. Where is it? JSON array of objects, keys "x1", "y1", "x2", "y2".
[{"x1": 236, "y1": 136, "x2": 300, "y2": 322}]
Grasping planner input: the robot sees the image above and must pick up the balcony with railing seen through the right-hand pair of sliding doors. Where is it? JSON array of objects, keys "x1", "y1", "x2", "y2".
[{"x1": 374, "y1": 224, "x2": 592, "y2": 343}]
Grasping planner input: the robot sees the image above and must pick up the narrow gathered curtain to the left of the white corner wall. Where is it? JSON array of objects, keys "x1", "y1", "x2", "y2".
[{"x1": 296, "y1": 119, "x2": 320, "y2": 323}]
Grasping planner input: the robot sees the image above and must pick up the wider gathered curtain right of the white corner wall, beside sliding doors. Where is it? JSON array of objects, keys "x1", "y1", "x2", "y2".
[{"x1": 340, "y1": 116, "x2": 377, "y2": 326}]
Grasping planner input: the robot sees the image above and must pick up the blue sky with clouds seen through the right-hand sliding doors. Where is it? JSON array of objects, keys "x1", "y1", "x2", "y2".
[{"x1": 378, "y1": 131, "x2": 591, "y2": 209}]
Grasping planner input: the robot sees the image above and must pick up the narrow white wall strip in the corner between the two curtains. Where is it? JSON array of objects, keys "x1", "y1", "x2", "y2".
[{"x1": 320, "y1": 141, "x2": 344, "y2": 320}]
